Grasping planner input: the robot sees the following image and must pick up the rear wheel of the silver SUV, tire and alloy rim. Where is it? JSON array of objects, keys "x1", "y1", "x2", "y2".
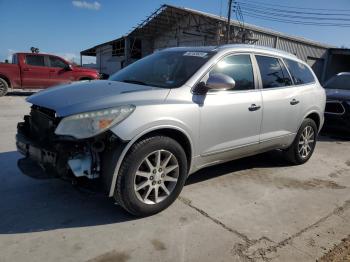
[{"x1": 285, "y1": 118, "x2": 318, "y2": 165}]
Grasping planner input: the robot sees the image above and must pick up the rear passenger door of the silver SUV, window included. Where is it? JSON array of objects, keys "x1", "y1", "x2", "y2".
[{"x1": 255, "y1": 55, "x2": 300, "y2": 148}]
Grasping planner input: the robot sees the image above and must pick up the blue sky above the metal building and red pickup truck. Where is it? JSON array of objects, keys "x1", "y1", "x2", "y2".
[{"x1": 0, "y1": 0, "x2": 350, "y2": 63}]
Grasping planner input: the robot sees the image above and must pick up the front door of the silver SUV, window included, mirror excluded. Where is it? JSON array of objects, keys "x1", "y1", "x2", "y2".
[{"x1": 200, "y1": 54, "x2": 262, "y2": 164}]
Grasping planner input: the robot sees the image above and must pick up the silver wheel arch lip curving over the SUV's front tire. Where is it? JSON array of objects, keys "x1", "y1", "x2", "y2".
[{"x1": 109, "y1": 125, "x2": 194, "y2": 197}]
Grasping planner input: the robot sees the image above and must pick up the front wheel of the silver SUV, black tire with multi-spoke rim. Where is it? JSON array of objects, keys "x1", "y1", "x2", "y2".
[{"x1": 114, "y1": 136, "x2": 187, "y2": 217}]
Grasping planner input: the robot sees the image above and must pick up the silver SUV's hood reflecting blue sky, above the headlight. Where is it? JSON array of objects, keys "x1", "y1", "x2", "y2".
[{"x1": 27, "y1": 80, "x2": 170, "y2": 117}]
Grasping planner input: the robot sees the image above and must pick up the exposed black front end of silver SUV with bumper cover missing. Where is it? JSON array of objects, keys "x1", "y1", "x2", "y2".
[{"x1": 16, "y1": 106, "x2": 120, "y2": 180}]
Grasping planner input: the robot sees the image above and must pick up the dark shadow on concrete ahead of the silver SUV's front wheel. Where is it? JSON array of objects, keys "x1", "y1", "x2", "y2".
[{"x1": 0, "y1": 151, "x2": 136, "y2": 234}]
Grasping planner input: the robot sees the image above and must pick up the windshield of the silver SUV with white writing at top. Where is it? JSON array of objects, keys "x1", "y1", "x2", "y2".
[{"x1": 109, "y1": 51, "x2": 214, "y2": 88}]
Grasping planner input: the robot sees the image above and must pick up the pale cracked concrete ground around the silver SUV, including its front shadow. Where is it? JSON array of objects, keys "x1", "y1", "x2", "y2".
[{"x1": 0, "y1": 92, "x2": 350, "y2": 262}]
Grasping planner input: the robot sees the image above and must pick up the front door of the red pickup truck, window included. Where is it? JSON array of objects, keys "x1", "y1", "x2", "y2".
[{"x1": 48, "y1": 56, "x2": 74, "y2": 85}]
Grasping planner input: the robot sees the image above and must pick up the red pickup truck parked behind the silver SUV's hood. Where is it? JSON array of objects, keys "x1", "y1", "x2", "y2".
[{"x1": 0, "y1": 53, "x2": 99, "y2": 96}]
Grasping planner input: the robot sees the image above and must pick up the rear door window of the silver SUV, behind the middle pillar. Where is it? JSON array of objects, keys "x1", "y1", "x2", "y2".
[{"x1": 255, "y1": 55, "x2": 292, "y2": 88}]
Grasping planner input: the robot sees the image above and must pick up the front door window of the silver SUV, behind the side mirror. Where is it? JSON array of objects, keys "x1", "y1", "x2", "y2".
[{"x1": 209, "y1": 55, "x2": 255, "y2": 90}]
